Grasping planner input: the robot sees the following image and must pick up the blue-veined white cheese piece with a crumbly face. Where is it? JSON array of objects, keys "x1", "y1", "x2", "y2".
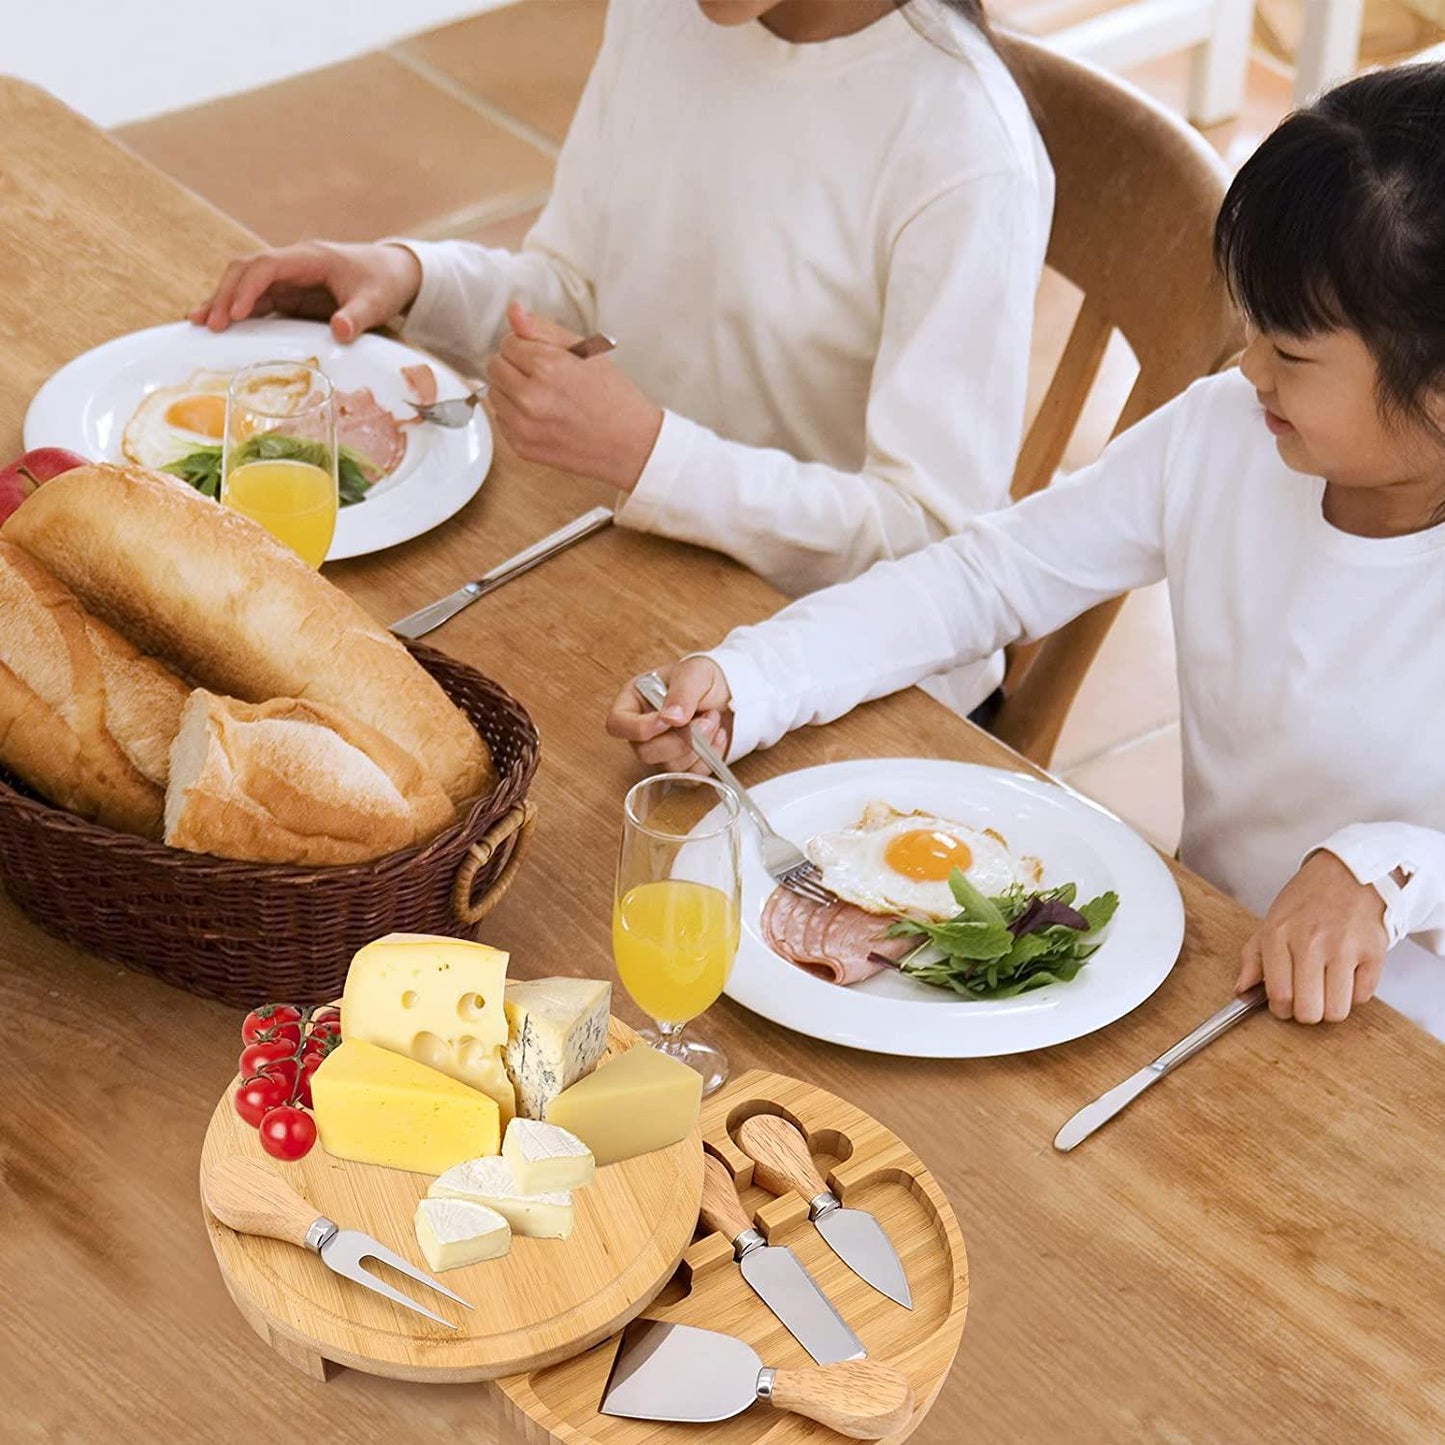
[{"x1": 506, "y1": 978, "x2": 613, "y2": 1118}]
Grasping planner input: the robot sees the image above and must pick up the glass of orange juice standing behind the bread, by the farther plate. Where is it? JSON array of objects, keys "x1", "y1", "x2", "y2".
[{"x1": 221, "y1": 361, "x2": 338, "y2": 566}]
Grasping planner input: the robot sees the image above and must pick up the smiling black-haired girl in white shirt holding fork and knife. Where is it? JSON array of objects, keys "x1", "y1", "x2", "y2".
[{"x1": 608, "y1": 65, "x2": 1445, "y2": 1038}]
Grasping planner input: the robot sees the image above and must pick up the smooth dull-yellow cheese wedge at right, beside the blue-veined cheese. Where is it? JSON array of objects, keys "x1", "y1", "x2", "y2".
[{"x1": 546, "y1": 1043, "x2": 702, "y2": 1165}]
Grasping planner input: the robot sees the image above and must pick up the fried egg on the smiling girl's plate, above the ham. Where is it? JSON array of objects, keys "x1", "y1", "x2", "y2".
[{"x1": 805, "y1": 802, "x2": 1043, "y2": 919}]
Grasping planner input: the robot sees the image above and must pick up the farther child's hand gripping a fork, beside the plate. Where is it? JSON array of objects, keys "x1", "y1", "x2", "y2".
[{"x1": 487, "y1": 303, "x2": 662, "y2": 491}]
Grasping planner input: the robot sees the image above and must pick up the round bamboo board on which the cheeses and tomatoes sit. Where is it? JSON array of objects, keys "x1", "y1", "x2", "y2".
[{"x1": 201, "y1": 1019, "x2": 702, "y2": 1384}]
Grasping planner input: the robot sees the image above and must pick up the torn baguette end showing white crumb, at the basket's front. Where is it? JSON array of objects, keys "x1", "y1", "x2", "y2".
[{"x1": 165, "y1": 688, "x2": 455, "y2": 866}]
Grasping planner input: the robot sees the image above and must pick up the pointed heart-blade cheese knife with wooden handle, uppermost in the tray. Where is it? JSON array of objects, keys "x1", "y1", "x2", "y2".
[{"x1": 737, "y1": 1114, "x2": 913, "y2": 1309}]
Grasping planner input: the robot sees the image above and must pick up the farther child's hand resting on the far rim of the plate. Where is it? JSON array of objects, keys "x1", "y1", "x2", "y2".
[{"x1": 191, "y1": 241, "x2": 422, "y2": 342}]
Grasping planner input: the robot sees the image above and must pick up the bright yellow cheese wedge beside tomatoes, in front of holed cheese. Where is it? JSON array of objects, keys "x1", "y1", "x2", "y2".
[{"x1": 311, "y1": 1039, "x2": 501, "y2": 1175}]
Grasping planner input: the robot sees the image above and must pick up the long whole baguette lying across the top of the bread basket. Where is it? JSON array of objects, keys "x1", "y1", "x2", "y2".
[{"x1": 0, "y1": 465, "x2": 496, "y2": 803}]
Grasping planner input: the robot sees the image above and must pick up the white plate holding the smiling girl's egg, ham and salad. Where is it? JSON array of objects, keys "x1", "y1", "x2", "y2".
[{"x1": 727, "y1": 757, "x2": 1183, "y2": 1059}]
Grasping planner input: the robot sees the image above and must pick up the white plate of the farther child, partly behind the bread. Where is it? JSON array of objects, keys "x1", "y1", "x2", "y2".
[{"x1": 25, "y1": 318, "x2": 491, "y2": 562}]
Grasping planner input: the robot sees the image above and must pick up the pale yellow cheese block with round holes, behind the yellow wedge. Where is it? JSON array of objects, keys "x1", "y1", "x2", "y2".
[{"x1": 341, "y1": 933, "x2": 516, "y2": 1121}]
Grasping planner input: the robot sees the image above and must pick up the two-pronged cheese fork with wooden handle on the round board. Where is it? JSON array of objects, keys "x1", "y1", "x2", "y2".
[{"x1": 202, "y1": 1155, "x2": 473, "y2": 1329}]
